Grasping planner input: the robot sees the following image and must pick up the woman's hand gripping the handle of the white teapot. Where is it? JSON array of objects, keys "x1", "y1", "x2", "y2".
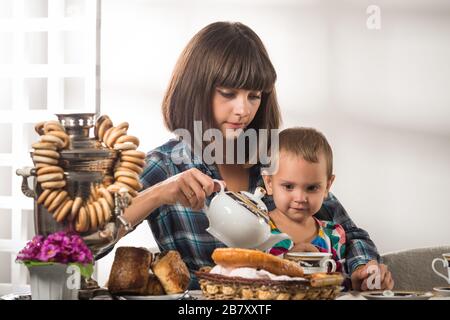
[{"x1": 157, "y1": 168, "x2": 224, "y2": 210}]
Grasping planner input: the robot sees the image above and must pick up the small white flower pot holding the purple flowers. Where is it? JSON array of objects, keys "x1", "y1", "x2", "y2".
[{"x1": 28, "y1": 263, "x2": 78, "y2": 300}]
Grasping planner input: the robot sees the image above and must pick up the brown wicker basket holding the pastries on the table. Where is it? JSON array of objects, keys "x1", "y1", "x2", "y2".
[{"x1": 196, "y1": 271, "x2": 344, "y2": 300}]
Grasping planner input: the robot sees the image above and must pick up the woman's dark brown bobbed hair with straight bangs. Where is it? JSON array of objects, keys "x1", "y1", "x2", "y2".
[{"x1": 162, "y1": 22, "x2": 281, "y2": 152}]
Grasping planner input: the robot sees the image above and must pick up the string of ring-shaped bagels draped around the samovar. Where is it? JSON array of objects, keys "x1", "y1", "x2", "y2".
[{"x1": 32, "y1": 115, "x2": 145, "y2": 233}]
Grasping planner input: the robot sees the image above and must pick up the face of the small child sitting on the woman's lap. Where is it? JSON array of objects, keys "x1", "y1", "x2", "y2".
[{"x1": 264, "y1": 150, "x2": 334, "y2": 222}]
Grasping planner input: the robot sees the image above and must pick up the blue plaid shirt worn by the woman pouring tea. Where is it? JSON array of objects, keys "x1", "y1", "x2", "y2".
[{"x1": 141, "y1": 139, "x2": 380, "y2": 288}]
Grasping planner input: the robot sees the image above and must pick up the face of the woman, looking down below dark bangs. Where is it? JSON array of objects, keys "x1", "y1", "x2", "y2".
[{"x1": 212, "y1": 87, "x2": 262, "y2": 138}]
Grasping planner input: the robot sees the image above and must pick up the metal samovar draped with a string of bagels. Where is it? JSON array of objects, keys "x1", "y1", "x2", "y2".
[{"x1": 16, "y1": 113, "x2": 132, "y2": 259}]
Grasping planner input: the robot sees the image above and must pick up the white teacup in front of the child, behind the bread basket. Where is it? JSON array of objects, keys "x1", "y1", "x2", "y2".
[{"x1": 284, "y1": 252, "x2": 336, "y2": 274}]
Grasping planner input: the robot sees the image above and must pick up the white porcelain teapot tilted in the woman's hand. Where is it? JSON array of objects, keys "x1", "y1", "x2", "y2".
[{"x1": 204, "y1": 180, "x2": 290, "y2": 251}]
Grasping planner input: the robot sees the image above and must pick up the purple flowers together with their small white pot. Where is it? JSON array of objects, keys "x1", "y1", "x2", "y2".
[{"x1": 16, "y1": 232, "x2": 94, "y2": 300}]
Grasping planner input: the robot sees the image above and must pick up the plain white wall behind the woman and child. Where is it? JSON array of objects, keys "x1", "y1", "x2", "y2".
[{"x1": 98, "y1": 0, "x2": 450, "y2": 282}]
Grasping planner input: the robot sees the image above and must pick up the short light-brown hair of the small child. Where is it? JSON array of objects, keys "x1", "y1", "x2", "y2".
[{"x1": 279, "y1": 127, "x2": 333, "y2": 179}]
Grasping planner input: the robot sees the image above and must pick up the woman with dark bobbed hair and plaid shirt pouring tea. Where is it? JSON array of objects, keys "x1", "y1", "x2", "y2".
[{"x1": 125, "y1": 22, "x2": 387, "y2": 288}]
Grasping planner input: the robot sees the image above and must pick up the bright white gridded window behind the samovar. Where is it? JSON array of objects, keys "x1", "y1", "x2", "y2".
[{"x1": 0, "y1": 0, "x2": 100, "y2": 295}]
